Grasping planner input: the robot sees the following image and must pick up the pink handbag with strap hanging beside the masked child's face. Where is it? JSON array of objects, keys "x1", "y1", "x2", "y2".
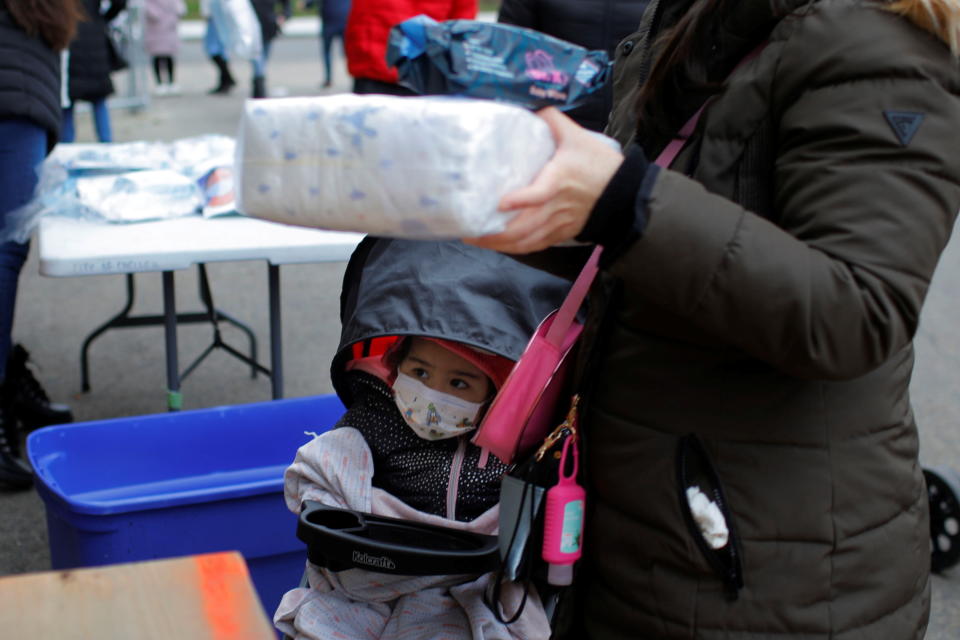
[{"x1": 473, "y1": 247, "x2": 602, "y2": 466}]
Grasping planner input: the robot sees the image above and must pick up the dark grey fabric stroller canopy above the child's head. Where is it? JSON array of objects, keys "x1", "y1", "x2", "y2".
[{"x1": 330, "y1": 236, "x2": 570, "y2": 406}]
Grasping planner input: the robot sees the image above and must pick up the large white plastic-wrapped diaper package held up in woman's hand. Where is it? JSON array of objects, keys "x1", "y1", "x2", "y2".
[{"x1": 234, "y1": 94, "x2": 554, "y2": 239}]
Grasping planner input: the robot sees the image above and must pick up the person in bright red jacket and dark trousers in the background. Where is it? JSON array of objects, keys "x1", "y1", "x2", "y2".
[{"x1": 344, "y1": 0, "x2": 477, "y2": 95}]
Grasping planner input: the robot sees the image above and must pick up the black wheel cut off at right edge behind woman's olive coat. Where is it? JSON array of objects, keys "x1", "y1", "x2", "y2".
[{"x1": 923, "y1": 468, "x2": 960, "y2": 573}]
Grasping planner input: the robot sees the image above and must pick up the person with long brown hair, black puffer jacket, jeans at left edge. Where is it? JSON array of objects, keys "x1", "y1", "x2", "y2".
[{"x1": 0, "y1": 0, "x2": 82, "y2": 489}]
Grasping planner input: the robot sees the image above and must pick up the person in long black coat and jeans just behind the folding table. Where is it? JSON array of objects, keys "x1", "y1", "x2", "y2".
[{"x1": 60, "y1": 0, "x2": 127, "y2": 142}]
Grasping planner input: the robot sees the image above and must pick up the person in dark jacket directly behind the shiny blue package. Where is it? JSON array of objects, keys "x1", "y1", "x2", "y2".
[{"x1": 497, "y1": 0, "x2": 649, "y2": 131}]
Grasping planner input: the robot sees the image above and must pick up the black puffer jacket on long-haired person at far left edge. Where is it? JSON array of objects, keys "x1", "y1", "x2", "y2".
[{"x1": 0, "y1": 0, "x2": 61, "y2": 151}]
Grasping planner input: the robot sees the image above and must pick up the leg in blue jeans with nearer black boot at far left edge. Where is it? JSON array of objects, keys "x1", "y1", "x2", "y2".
[{"x1": 0, "y1": 120, "x2": 47, "y2": 489}]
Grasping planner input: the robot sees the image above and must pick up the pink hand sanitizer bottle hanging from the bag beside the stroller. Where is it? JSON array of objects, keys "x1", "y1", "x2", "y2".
[{"x1": 542, "y1": 436, "x2": 587, "y2": 586}]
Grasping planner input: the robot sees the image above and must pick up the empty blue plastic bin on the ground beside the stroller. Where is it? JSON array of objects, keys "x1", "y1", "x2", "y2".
[{"x1": 27, "y1": 394, "x2": 344, "y2": 616}]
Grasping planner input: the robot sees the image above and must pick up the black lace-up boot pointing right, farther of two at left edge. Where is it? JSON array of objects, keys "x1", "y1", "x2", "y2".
[{"x1": 0, "y1": 344, "x2": 73, "y2": 431}]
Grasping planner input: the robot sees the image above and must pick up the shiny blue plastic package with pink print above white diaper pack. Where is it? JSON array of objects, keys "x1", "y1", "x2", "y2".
[{"x1": 387, "y1": 15, "x2": 610, "y2": 109}]
